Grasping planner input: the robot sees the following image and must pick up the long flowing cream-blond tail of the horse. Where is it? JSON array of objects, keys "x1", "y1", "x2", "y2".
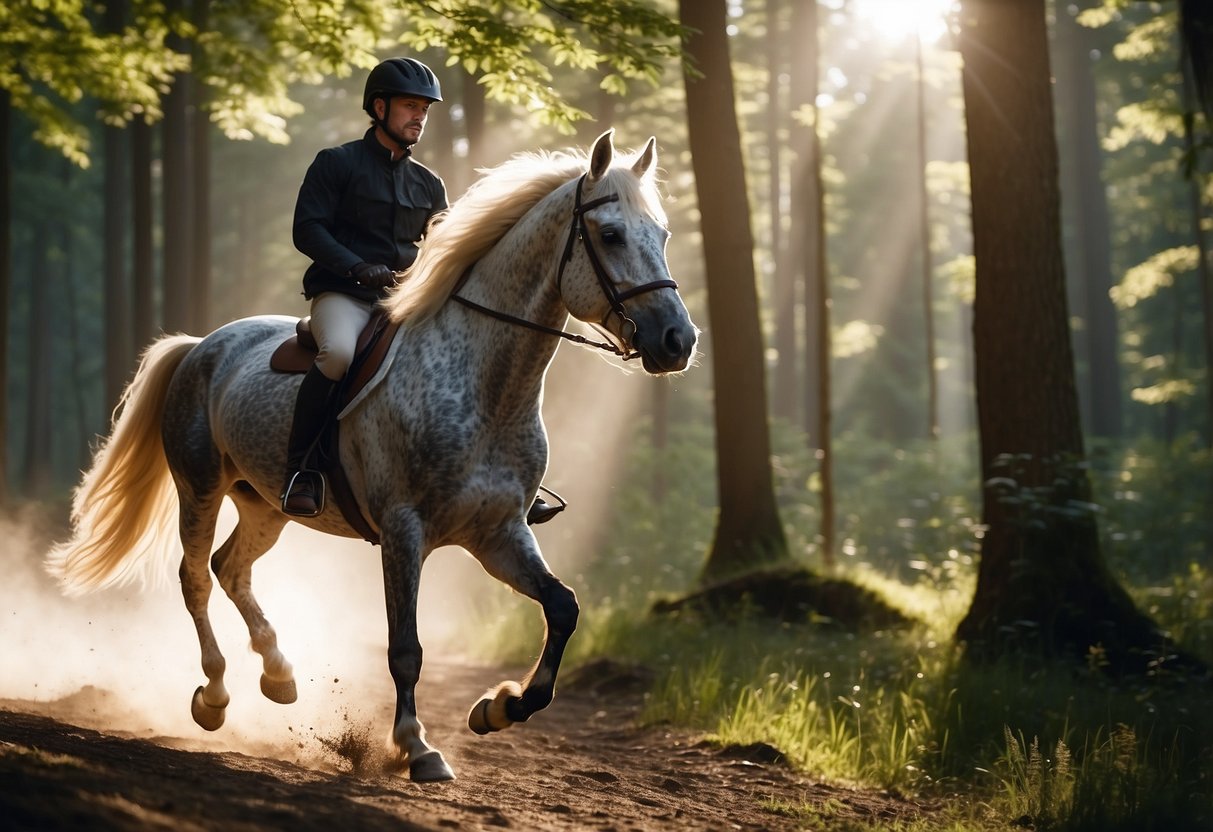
[{"x1": 46, "y1": 335, "x2": 200, "y2": 595}]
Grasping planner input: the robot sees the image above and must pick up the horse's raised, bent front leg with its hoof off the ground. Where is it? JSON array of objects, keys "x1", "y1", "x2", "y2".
[{"x1": 467, "y1": 525, "x2": 579, "y2": 734}]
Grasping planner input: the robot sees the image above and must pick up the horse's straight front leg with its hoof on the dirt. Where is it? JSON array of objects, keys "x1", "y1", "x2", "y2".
[{"x1": 381, "y1": 509, "x2": 455, "y2": 782}]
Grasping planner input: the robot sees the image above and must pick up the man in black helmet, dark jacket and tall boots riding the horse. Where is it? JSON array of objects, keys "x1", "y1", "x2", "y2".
[{"x1": 281, "y1": 58, "x2": 564, "y2": 523}]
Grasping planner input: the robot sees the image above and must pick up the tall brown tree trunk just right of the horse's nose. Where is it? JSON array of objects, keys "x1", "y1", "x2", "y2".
[{"x1": 679, "y1": 0, "x2": 787, "y2": 581}]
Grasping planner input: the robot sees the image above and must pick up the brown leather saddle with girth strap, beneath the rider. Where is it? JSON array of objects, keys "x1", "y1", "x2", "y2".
[{"x1": 269, "y1": 307, "x2": 400, "y2": 543}]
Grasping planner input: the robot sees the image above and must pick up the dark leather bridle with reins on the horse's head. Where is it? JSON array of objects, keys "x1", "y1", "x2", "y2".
[{"x1": 451, "y1": 173, "x2": 678, "y2": 361}]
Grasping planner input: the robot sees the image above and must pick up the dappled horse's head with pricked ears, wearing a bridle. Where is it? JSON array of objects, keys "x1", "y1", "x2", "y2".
[{"x1": 559, "y1": 130, "x2": 699, "y2": 374}]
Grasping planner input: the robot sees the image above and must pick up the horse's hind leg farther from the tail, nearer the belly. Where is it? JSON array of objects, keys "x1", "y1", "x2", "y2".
[{"x1": 211, "y1": 484, "x2": 297, "y2": 705}]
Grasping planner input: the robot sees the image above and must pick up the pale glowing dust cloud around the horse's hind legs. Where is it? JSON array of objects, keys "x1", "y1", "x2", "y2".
[{"x1": 0, "y1": 506, "x2": 494, "y2": 756}]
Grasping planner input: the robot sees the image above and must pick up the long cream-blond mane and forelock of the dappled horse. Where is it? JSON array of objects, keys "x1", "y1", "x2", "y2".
[{"x1": 383, "y1": 143, "x2": 666, "y2": 323}]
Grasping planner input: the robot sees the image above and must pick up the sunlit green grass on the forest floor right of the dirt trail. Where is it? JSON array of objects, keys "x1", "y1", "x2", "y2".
[{"x1": 458, "y1": 568, "x2": 1213, "y2": 832}]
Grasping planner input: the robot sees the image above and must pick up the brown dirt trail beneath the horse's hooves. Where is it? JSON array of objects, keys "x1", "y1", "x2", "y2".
[{"x1": 0, "y1": 662, "x2": 923, "y2": 831}]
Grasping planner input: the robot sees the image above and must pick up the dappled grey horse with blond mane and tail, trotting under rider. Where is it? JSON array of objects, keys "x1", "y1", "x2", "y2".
[{"x1": 46, "y1": 130, "x2": 699, "y2": 781}]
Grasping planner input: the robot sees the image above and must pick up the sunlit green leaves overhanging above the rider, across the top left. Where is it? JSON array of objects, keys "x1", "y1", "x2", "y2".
[{"x1": 0, "y1": 0, "x2": 683, "y2": 165}]
